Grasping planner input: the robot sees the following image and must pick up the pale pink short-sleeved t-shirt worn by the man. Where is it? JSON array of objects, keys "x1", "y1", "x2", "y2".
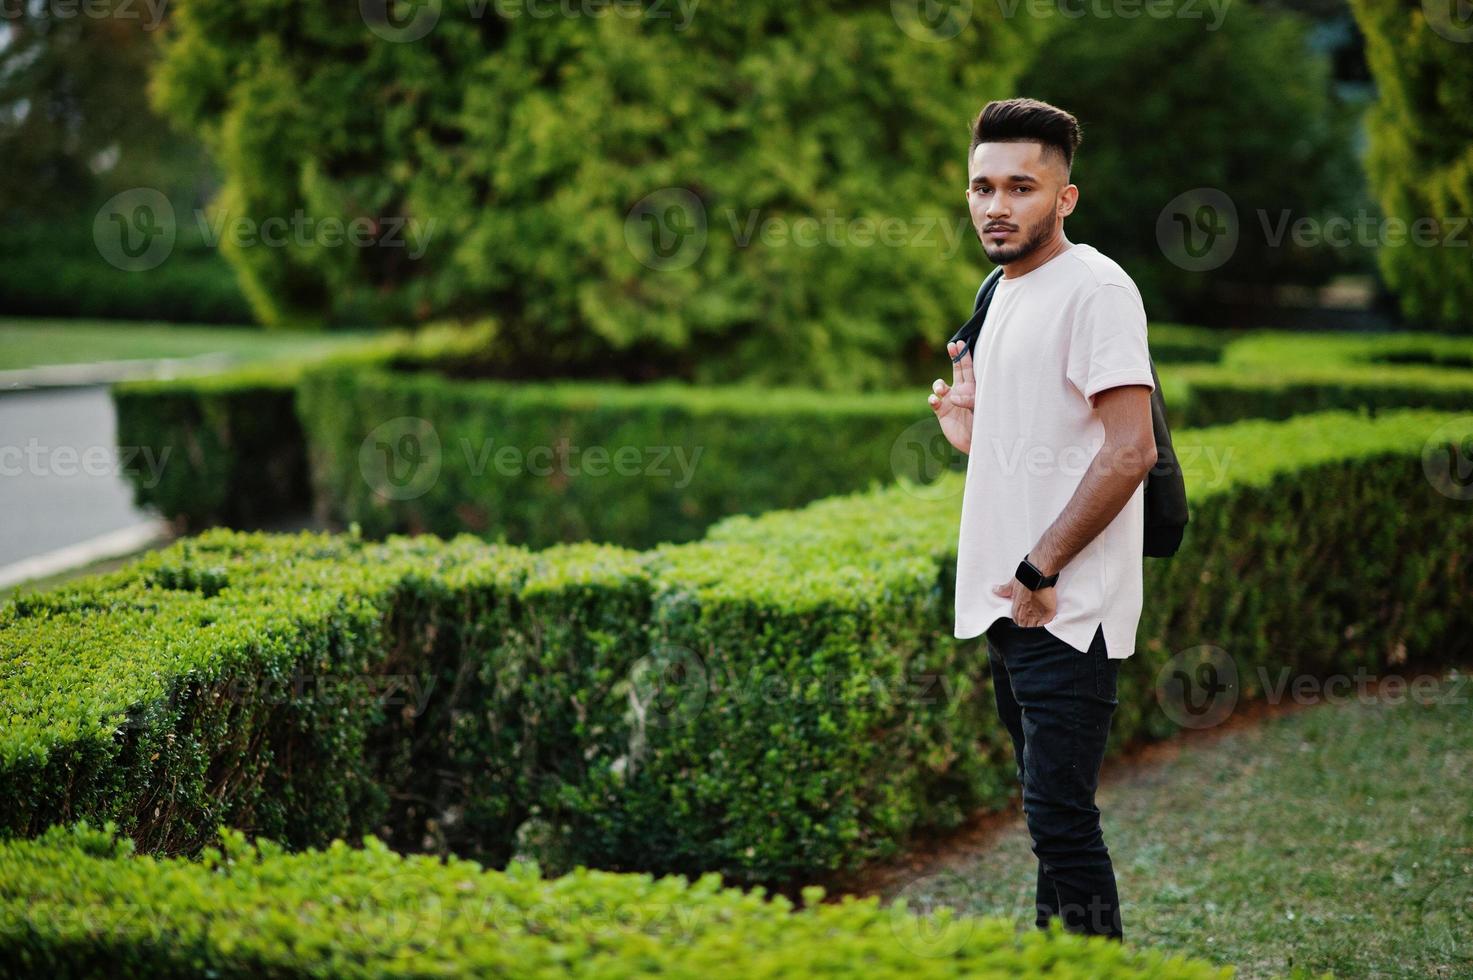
[{"x1": 955, "y1": 243, "x2": 1155, "y2": 659}]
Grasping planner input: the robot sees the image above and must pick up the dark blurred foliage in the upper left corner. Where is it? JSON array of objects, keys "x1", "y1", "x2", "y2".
[{"x1": 0, "y1": 0, "x2": 250, "y2": 323}]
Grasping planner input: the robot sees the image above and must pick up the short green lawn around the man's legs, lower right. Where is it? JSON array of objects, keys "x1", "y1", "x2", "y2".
[{"x1": 882, "y1": 672, "x2": 1473, "y2": 977}]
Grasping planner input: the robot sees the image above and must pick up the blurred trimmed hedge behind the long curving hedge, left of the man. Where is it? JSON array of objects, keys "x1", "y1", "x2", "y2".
[{"x1": 298, "y1": 365, "x2": 925, "y2": 547}]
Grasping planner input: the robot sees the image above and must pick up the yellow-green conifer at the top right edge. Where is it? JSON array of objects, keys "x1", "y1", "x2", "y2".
[{"x1": 1351, "y1": 0, "x2": 1473, "y2": 332}]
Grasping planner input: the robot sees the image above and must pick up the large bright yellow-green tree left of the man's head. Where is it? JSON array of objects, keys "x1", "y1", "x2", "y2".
[{"x1": 155, "y1": 0, "x2": 1043, "y2": 388}]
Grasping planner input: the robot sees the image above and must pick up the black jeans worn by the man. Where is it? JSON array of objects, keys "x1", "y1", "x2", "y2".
[{"x1": 987, "y1": 616, "x2": 1124, "y2": 940}]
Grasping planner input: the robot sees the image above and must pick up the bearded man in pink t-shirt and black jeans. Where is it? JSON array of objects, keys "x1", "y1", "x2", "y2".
[{"x1": 929, "y1": 99, "x2": 1156, "y2": 940}]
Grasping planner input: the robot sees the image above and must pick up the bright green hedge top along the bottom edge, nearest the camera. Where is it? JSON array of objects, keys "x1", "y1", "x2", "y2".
[{"x1": 0, "y1": 825, "x2": 1233, "y2": 980}]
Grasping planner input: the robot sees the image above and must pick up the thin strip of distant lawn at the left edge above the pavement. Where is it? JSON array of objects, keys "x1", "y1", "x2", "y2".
[{"x1": 0, "y1": 317, "x2": 377, "y2": 371}]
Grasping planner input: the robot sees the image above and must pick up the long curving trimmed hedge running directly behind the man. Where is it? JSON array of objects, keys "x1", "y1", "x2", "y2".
[{"x1": 0, "y1": 411, "x2": 1473, "y2": 883}]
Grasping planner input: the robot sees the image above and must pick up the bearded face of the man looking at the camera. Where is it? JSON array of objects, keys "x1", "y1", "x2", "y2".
[{"x1": 966, "y1": 143, "x2": 1078, "y2": 265}]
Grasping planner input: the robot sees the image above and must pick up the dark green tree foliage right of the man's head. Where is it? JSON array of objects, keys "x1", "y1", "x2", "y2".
[{"x1": 1018, "y1": 3, "x2": 1370, "y2": 320}]
